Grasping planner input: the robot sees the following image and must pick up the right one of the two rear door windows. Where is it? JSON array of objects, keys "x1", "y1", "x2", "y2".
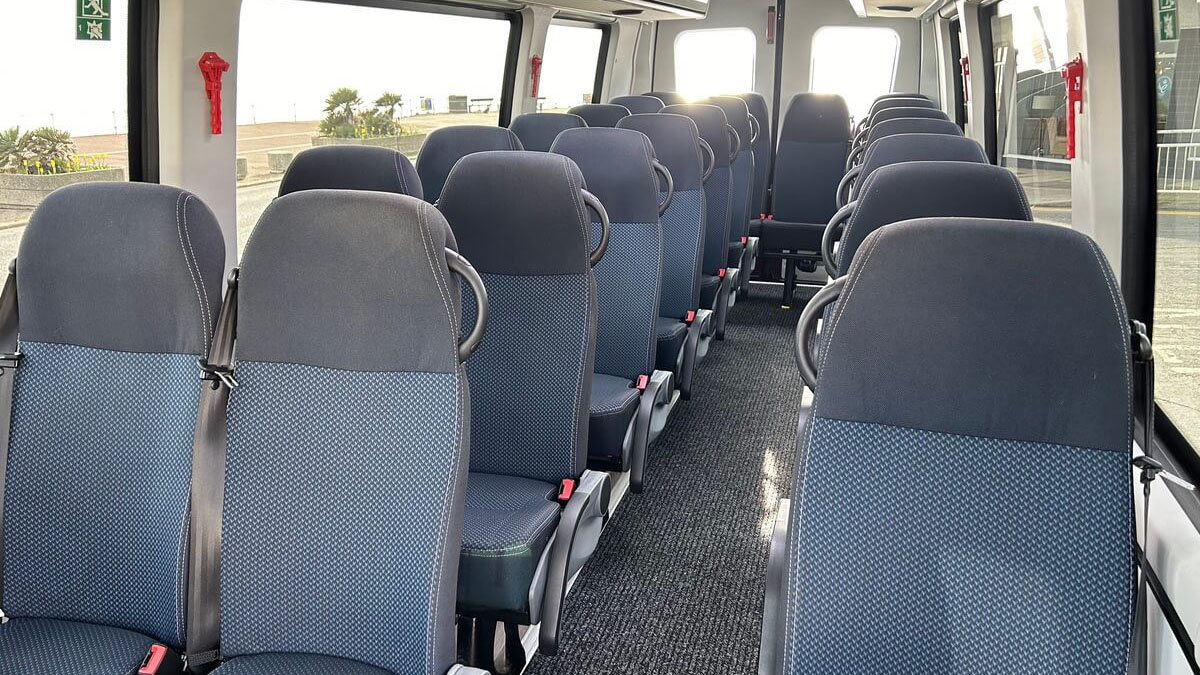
[{"x1": 811, "y1": 25, "x2": 900, "y2": 120}]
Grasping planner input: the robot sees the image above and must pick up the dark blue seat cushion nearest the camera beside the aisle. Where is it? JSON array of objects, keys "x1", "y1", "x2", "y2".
[{"x1": 458, "y1": 473, "x2": 560, "y2": 619}]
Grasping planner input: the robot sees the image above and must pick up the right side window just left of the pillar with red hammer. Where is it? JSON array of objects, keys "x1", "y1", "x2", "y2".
[{"x1": 991, "y1": 0, "x2": 1073, "y2": 225}]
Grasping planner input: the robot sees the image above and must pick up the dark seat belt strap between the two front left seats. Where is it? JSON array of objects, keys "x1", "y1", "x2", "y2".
[{"x1": 186, "y1": 268, "x2": 238, "y2": 673}]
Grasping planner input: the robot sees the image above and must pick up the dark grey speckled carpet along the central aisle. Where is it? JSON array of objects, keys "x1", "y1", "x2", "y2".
[{"x1": 527, "y1": 286, "x2": 804, "y2": 675}]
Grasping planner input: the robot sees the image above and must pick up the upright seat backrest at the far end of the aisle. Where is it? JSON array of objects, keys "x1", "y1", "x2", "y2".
[{"x1": 772, "y1": 94, "x2": 850, "y2": 223}]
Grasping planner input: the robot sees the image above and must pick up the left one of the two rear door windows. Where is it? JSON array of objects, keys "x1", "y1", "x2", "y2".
[{"x1": 674, "y1": 28, "x2": 757, "y2": 100}]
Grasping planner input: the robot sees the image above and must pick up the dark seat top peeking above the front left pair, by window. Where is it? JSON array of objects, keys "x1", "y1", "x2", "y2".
[{"x1": 280, "y1": 145, "x2": 424, "y2": 199}]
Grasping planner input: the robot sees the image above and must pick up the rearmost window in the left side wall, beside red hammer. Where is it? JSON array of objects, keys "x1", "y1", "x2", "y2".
[{"x1": 538, "y1": 22, "x2": 604, "y2": 112}]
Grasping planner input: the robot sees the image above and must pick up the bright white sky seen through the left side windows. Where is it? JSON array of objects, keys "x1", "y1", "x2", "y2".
[{"x1": 0, "y1": 0, "x2": 600, "y2": 136}]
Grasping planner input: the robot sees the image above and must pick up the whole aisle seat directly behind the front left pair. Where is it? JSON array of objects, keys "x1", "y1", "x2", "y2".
[{"x1": 439, "y1": 151, "x2": 610, "y2": 670}]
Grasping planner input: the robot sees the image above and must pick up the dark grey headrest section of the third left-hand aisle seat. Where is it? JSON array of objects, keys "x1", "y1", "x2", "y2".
[{"x1": 550, "y1": 127, "x2": 659, "y2": 222}]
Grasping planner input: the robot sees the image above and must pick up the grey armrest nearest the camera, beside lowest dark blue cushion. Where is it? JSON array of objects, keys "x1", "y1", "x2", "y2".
[{"x1": 538, "y1": 471, "x2": 612, "y2": 656}]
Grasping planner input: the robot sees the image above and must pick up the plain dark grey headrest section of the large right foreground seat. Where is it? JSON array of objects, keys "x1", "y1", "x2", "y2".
[{"x1": 812, "y1": 219, "x2": 1132, "y2": 451}]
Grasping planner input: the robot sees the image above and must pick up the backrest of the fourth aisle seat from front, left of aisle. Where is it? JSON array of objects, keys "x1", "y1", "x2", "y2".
[{"x1": 617, "y1": 113, "x2": 706, "y2": 318}]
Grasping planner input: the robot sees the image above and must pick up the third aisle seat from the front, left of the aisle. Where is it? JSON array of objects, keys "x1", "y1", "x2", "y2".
[{"x1": 552, "y1": 129, "x2": 677, "y2": 492}]
